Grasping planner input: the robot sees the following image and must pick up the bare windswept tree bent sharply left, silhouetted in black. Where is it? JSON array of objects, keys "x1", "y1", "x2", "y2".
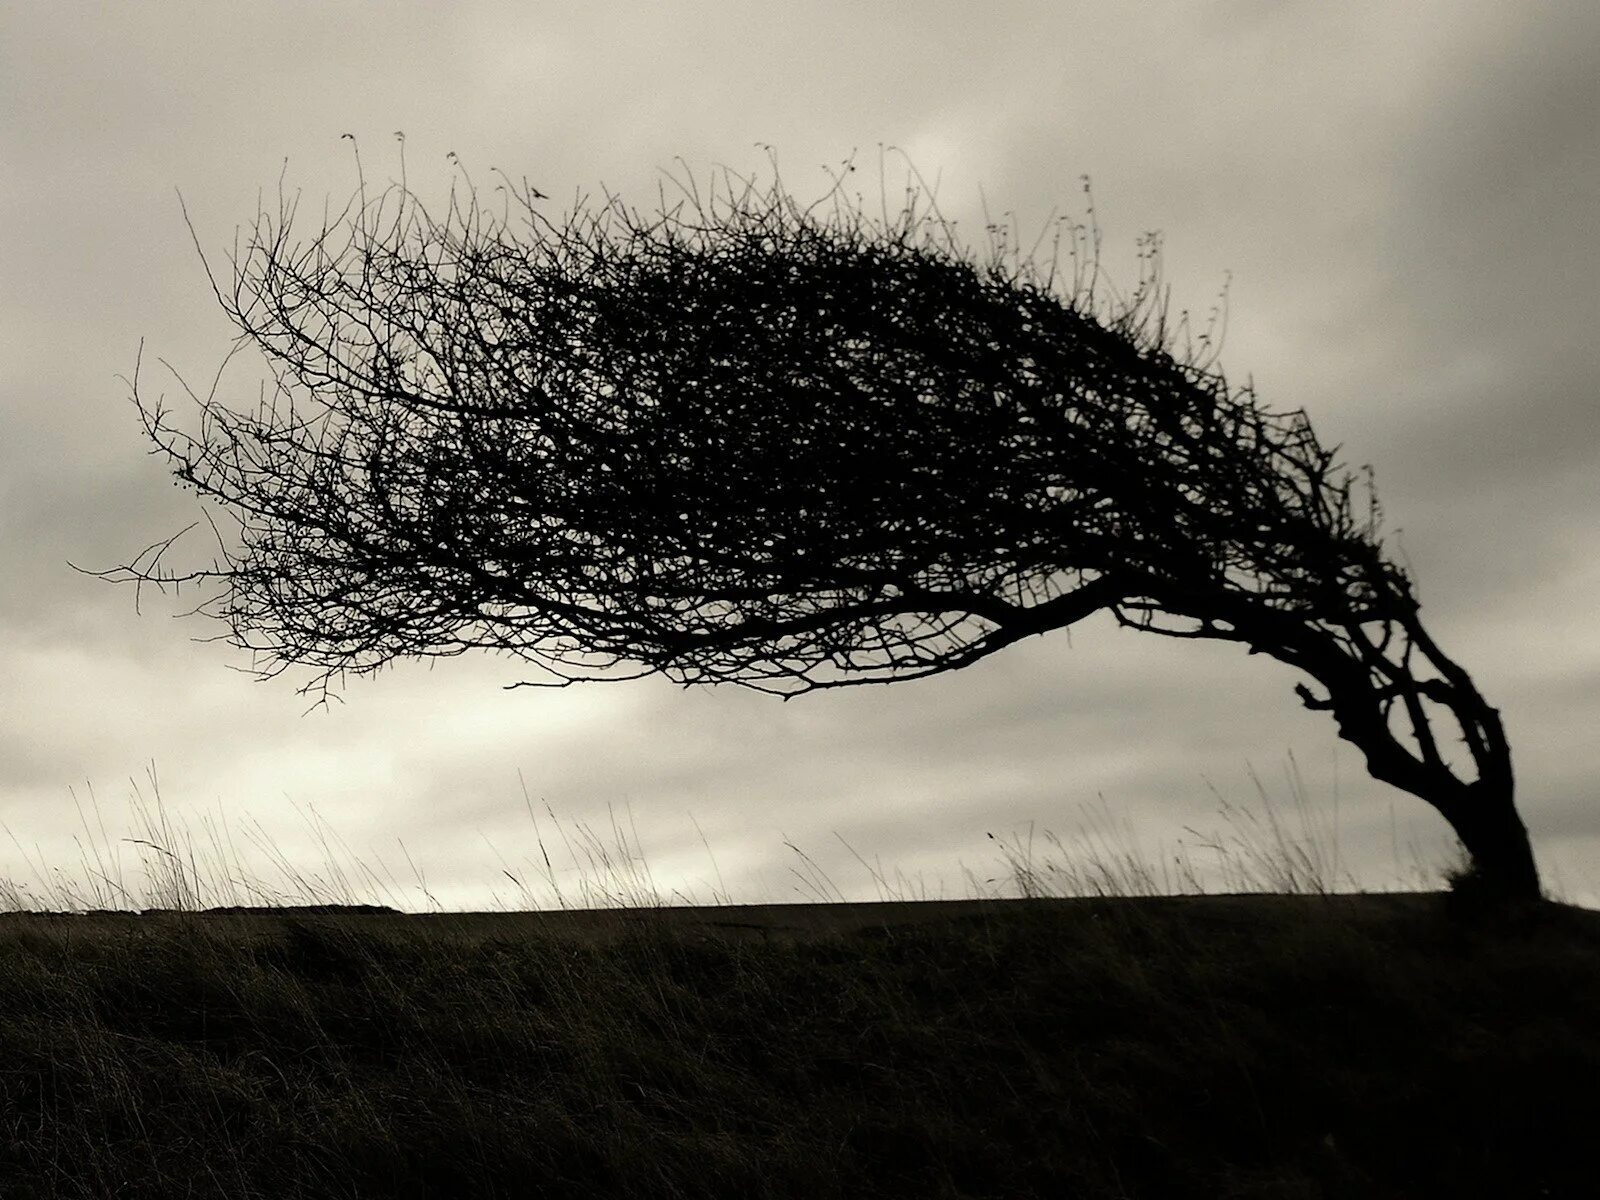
[{"x1": 104, "y1": 152, "x2": 1539, "y2": 899}]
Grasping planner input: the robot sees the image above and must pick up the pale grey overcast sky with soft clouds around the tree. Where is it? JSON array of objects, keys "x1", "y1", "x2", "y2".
[{"x1": 0, "y1": 0, "x2": 1600, "y2": 909}]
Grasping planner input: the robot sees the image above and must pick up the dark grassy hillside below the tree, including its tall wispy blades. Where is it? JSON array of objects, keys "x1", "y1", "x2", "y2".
[{"x1": 0, "y1": 764, "x2": 1600, "y2": 1200}]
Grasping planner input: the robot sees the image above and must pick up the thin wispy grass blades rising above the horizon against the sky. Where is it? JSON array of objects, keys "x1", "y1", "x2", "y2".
[{"x1": 0, "y1": 754, "x2": 1497, "y2": 912}]
